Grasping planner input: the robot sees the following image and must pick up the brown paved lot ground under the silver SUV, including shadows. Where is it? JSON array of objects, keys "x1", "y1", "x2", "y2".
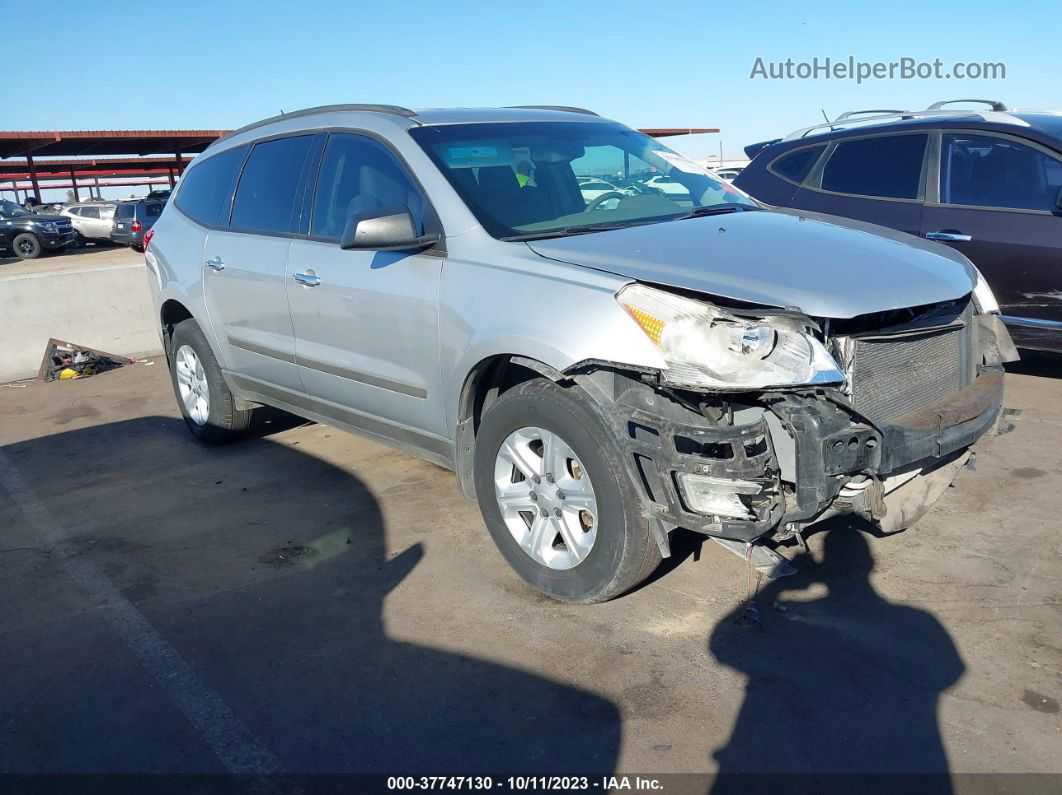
[{"x1": 0, "y1": 356, "x2": 1062, "y2": 782}]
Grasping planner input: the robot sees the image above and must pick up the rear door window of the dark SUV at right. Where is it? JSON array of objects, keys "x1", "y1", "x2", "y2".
[{"x1": 822, "y1": 134, "x2": 929, "y2": 198}]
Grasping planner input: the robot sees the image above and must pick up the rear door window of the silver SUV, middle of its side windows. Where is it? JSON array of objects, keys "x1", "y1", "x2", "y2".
[{"x1": 230, "y1": 135, "x2": 313, "y2": 232}]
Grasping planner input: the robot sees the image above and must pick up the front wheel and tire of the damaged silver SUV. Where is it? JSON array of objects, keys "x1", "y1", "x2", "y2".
[{"x1": 474, "y1": 379, "x2": 661, "y2": 604}]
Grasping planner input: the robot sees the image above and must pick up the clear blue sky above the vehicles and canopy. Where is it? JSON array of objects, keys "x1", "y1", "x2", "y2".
[{"x1": 0, "y1": 0, "x2": 1062, "y2": 197}]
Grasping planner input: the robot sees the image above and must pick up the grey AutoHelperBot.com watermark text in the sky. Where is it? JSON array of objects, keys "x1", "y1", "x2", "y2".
[{"x1": 749, "y1": 55, "x2": 1007, "y2": 83}]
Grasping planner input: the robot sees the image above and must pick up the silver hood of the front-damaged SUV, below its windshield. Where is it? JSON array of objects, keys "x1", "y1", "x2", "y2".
[{"x1": 528, "y1": 209, "x2": 977, "y2": 317}]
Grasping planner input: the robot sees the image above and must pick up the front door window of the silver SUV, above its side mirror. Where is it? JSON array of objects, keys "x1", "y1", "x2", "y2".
[{"x1": 311, "y1": 133, "x2": 424, "y2": 240}]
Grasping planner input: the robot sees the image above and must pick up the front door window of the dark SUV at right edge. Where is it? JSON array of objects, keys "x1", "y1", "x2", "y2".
[{"x1": 940, "y1": 133, "x2": 1062, "y2": 212}]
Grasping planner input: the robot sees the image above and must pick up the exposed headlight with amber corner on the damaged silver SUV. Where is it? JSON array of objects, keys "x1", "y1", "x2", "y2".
[{"x1": 616, "y1": 284, "x2": 844, "y2": 391}]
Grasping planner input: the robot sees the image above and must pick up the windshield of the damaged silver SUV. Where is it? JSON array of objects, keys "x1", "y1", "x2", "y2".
[{"x1": 410, "y1": 122, "x2": 757, "y2": 240}]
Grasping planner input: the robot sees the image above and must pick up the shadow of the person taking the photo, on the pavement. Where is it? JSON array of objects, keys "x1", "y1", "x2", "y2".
[{"x1": 708, "y1": 521, "x2": 964, "y2": 792}]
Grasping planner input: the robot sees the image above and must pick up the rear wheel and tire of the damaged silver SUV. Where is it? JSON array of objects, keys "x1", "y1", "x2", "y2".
[{"x1": 169, "y1": 317, "x2": 254, "y2": 445}]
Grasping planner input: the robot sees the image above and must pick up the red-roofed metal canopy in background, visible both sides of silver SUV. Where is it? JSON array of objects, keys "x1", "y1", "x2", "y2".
[{"x1": 0, "y1": 127, "x2": 719, "y2": 202}]
